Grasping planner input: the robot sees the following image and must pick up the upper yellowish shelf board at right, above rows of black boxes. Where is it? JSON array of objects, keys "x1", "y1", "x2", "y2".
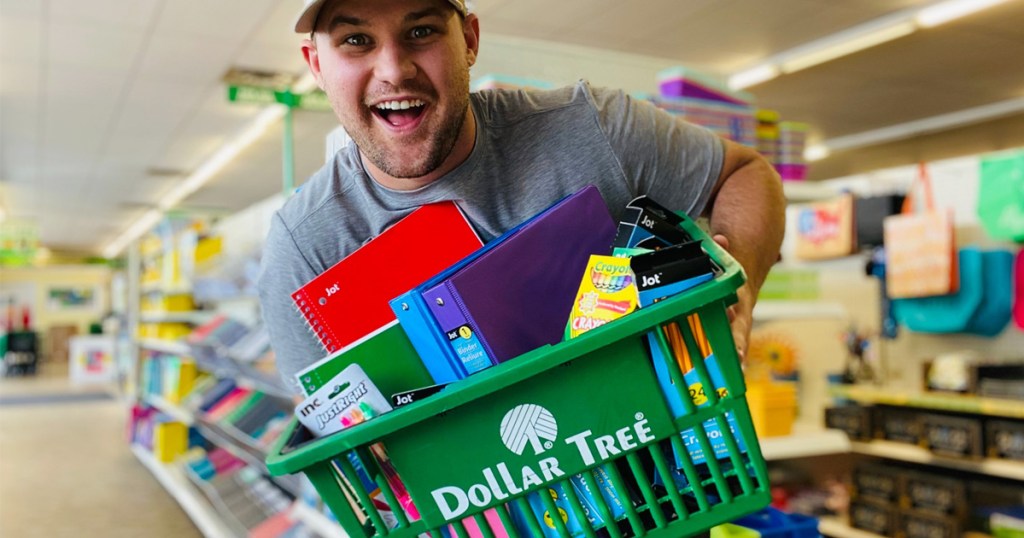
[{"x1": 828, "y1": 385, "x2": 1024, "y2": 418}]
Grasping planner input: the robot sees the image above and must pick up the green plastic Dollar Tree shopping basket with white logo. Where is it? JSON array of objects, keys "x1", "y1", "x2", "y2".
[{"x1": 267, "y1": 215, "x2": 770, "y2": 538}]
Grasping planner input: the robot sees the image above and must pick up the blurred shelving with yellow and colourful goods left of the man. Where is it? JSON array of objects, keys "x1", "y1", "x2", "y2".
[{"x1": 122, "y1": 197, "x2": 341, "y2": 538}]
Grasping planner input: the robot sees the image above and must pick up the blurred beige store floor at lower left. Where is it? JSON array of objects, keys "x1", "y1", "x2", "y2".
[{"x1": 0, "y1": 363, "x2": 202, "y2": 538}]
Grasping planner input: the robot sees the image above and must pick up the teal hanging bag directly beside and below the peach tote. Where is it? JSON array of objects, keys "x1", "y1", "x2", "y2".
[{"x1": 893, "y1": 247, "x2": 985, "y2": 333}]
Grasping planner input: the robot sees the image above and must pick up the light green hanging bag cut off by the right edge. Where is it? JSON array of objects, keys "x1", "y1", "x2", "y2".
[{"x1": 978, "y1": 152, "x2": 1024, "y2": 243}]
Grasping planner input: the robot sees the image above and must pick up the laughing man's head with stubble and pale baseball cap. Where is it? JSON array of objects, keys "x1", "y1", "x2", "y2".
[{"x1": 303, "y1": 0, "x2": 478, "y2": 178}]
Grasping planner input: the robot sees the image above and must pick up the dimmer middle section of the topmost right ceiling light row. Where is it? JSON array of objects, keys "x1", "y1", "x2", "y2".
[{"x1": 781, "y1": 20, "x2": 915, "y2": 73}]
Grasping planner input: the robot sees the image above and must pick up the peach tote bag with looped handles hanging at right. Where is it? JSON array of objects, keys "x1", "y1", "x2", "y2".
[{"x1": 883, "y1": 163, "x2": 958, "y2": 298}]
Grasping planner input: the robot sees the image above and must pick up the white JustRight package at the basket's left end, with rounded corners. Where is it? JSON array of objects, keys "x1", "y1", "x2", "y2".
[{"x1": 295, "y1": 364, "x2": 391, "y2": 438}]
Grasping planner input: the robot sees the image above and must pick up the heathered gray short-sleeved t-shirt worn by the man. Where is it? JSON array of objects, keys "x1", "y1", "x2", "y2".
[{"x1": 259, "y1": 82, "x2": 724, "y2": 392}]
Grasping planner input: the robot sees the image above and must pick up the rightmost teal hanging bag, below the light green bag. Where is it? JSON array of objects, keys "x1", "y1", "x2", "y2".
[{"x1": 967, "y1": 250, "x2": 1014, "y2": 336}]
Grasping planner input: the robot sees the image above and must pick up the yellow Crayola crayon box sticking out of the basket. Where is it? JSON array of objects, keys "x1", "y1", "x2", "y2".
[{"x1": 565, "y1": 255, "x2": 640, "y2": 339}]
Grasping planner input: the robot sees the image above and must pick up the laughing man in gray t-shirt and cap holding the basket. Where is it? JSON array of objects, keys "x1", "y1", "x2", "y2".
[{"x1": 259, "y1": 0, "x2": 784, "y2": 393}]
